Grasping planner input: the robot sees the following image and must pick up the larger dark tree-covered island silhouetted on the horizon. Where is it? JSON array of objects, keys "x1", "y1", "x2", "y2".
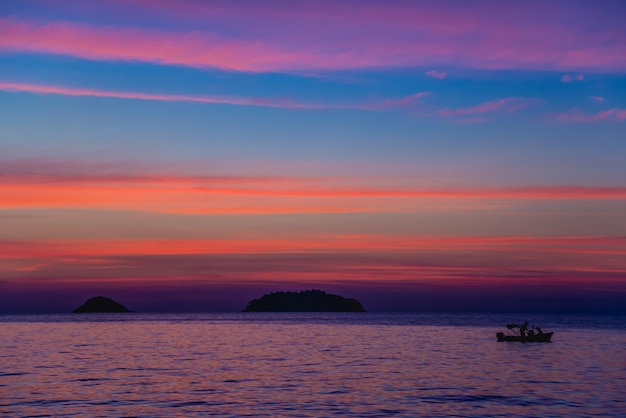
[{"x1": 243, "y1": 290, "x2": 365, "y2": 312}]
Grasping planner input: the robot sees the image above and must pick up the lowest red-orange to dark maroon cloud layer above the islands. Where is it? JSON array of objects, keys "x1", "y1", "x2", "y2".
[{"x1": 0, "y1": 233, "x2": 626, "y2": 311}]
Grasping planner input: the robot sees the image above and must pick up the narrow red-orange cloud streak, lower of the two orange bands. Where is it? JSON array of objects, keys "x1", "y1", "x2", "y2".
[{"x1": 0, "y1": 234, "x2": 626, "y2": 260}]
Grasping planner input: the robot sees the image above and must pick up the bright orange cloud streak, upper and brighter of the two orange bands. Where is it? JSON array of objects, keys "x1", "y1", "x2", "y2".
[{"x1": 0, "y1": 177, "x2": 626, "y2": 213}]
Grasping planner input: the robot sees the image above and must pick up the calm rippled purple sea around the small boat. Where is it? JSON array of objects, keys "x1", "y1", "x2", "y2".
[{"x1": 0, "y1": 313, "x2": 626, "y2": 417}]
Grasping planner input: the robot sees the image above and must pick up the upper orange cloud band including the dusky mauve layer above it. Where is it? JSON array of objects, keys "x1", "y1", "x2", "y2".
[{"x1": 0, "y1": 155, "x2": 626, "y2": 215}]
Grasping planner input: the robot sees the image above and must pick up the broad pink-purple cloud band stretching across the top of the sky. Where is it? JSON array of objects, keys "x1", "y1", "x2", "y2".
[{"x1": 0, "y1": 1, "x2": 626, "y2": 72}]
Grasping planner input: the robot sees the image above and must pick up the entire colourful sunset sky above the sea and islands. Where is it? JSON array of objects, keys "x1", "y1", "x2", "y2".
[{"x1": 0, "y1": 0, "x2": 626, "y2": 313}]
